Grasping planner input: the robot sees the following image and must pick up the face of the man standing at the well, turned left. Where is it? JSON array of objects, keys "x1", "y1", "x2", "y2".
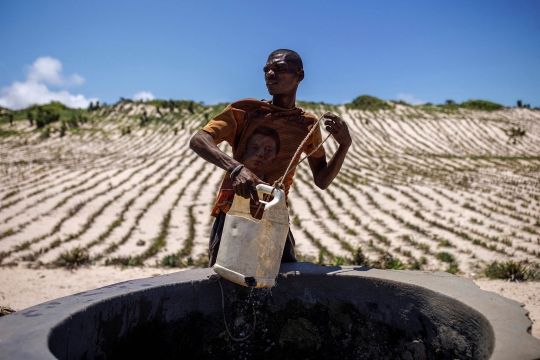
[{"x1": 263, "y1": 54, "x2": 304, "y2": 96}]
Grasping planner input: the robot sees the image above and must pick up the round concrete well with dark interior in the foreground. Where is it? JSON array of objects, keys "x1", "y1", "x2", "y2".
[{"x1": 0, "y1": 263, "x2": 540, "y2": 360}]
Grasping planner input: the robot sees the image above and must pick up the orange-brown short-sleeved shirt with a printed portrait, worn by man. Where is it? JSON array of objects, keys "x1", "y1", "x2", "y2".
[{"x1": 203, "y1": 99, "x2": 325, "y2": 216}]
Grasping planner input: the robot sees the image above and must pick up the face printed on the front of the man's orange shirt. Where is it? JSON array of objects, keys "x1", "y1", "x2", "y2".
[{"x1": 243, "y1": 134, "x2": 277, "y2": 176}]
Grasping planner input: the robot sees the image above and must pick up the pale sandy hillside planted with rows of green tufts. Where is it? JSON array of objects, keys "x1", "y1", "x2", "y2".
[{"x1": 0, "y1": 101, "x2": 540, "y2": 338}]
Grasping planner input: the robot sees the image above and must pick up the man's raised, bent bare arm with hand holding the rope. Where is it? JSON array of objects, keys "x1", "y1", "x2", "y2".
[{"x1": 308, "y1": 114, "x2": 352, "y2": 189}]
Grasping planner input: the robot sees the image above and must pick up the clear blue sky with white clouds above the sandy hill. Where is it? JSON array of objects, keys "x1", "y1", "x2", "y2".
[{"x1": 0, "y1": 0, "x2": 540, "y2": 108}]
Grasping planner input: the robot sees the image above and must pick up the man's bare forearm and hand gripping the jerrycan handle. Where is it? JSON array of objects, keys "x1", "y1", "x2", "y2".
[{"x1": 189, "y1": 130, "x2": 265, "y2": 203}]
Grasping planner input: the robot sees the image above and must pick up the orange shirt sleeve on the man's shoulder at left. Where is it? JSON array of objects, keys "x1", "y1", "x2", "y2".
[{"x1": 203, "y1": 105, "x2": 244, "y2": 146}]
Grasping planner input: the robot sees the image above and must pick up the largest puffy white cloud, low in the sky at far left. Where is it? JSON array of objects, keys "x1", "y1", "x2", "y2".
[{"x1": 0, "y1": 57, "x2": 95, "y2": 110}]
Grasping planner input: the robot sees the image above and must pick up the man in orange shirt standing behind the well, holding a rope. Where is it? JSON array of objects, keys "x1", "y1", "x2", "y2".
[{"x1": 190, "y1": 49, "x2": 352, "y2": 266}]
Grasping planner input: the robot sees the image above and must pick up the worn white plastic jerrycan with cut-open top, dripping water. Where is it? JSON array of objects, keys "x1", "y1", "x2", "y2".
[{"x1": 214, "y1": 184, "x2": 289, "y2": 288}]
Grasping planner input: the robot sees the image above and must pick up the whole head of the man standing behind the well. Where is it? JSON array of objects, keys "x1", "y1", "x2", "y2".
[{"x1": 263, "y1": 49, "x2": 304, "y2": 96}]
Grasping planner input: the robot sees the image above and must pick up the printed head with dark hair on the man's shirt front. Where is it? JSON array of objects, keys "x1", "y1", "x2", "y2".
[{"x1": 243, "y1": 126, "x2": 280, "y2": 177}]
